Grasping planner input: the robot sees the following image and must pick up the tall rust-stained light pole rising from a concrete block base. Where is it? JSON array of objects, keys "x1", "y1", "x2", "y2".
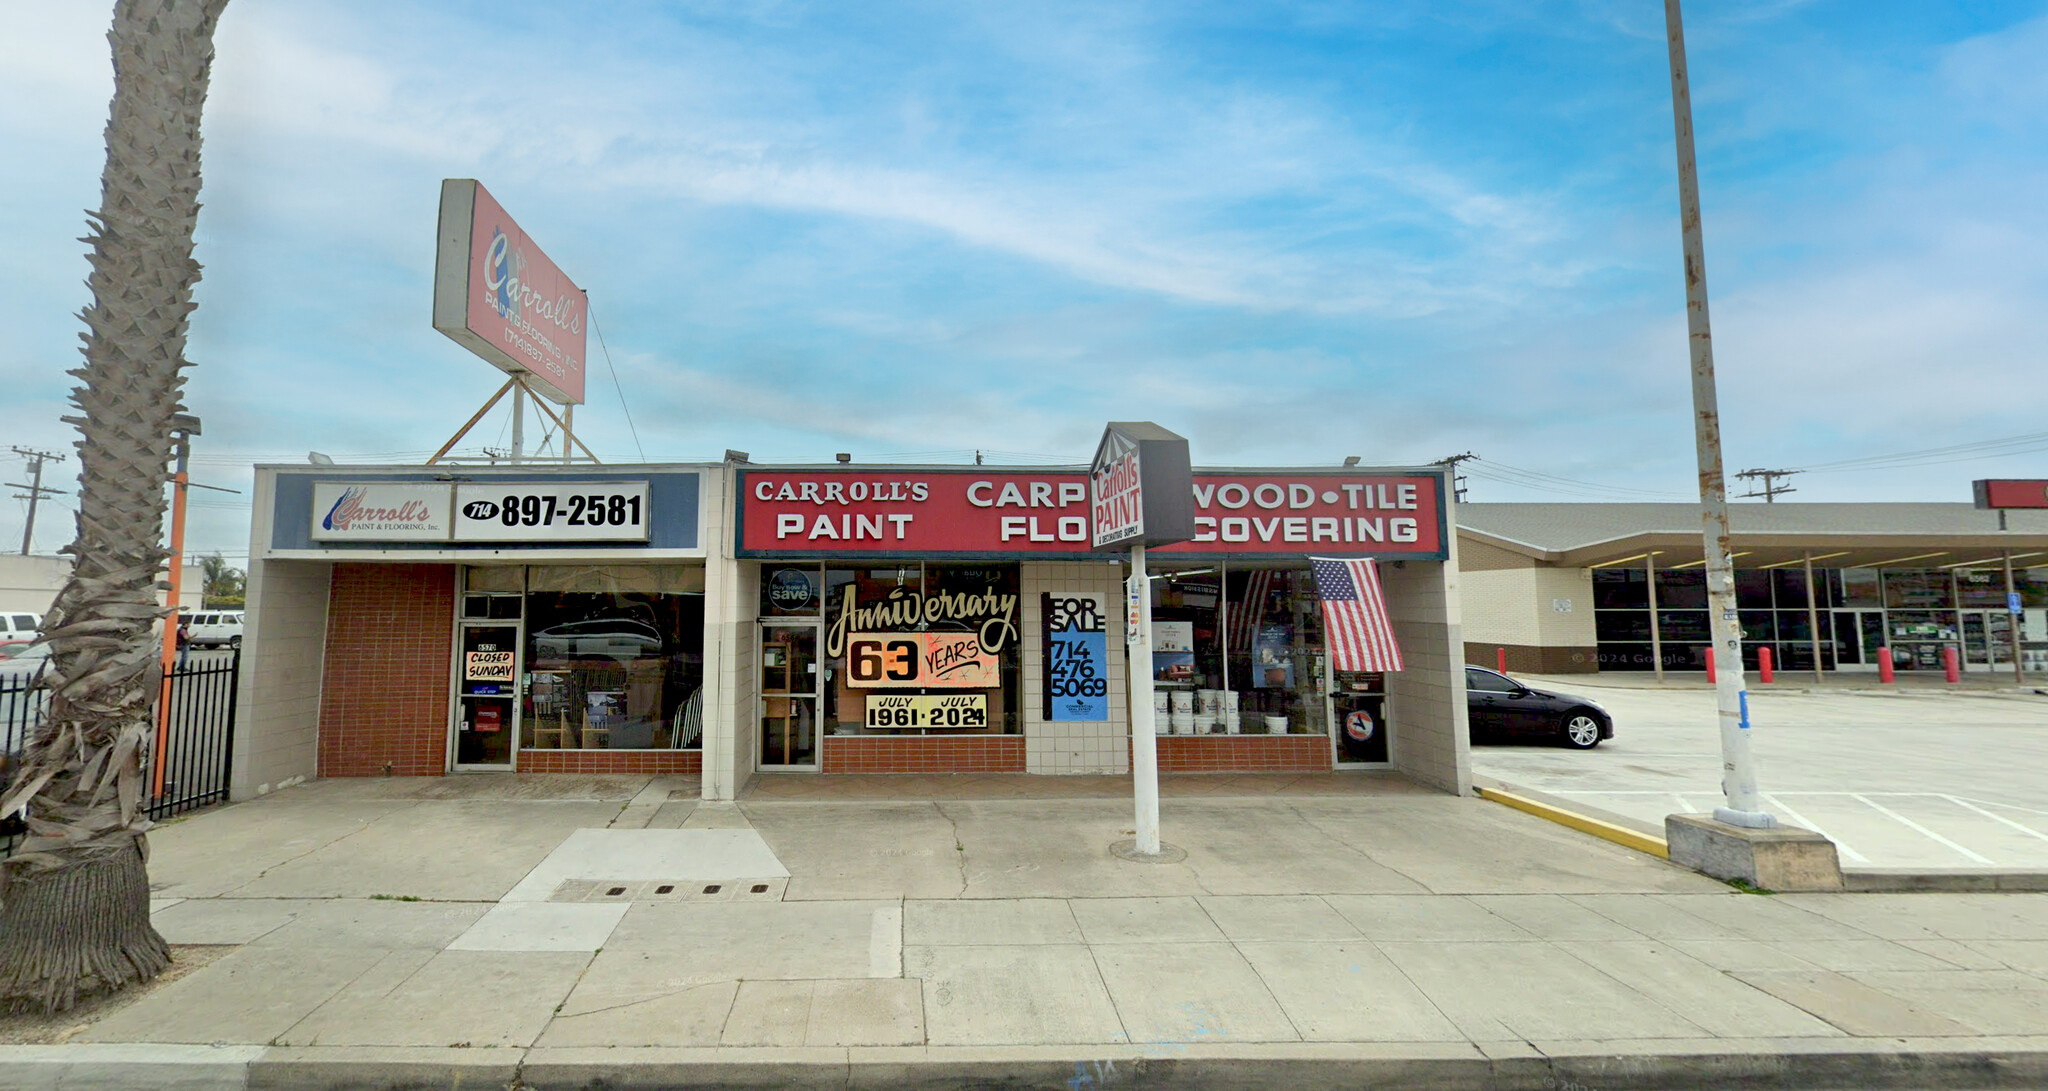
[{"x1": 1665, "y1": 0, "x2": 1778, "y2": 829}]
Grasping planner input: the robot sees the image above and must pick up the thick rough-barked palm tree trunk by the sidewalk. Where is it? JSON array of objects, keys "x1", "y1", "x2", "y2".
[{"x1": 0, "y1": 0, "x2": 227, "y2": 1011}]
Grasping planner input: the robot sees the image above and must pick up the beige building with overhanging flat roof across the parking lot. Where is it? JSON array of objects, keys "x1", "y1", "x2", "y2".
[{"x1": 1458, "y1": 504, "x2": 2048, "y2": 673}]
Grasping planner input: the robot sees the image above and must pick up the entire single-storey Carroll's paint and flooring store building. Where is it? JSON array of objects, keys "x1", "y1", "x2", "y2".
[{"x1": 233, "y1": 463, "x2": 1468, "y2": 798}]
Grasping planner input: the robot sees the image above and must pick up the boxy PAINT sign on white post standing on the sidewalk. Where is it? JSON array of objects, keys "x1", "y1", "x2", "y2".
[{"x1": 1087, "y1": 422, "x2": 1194, "y2": 860}]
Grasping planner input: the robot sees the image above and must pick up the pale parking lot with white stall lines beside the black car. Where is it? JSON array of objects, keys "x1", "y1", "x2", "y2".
[{"x1": 1473, "y1": 675, "x2": 2048, "y2": 870}]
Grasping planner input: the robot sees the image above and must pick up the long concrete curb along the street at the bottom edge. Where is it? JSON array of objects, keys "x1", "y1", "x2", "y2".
[{"x1": 12, "y1": 1038, "x2": 2048, "y2": 1091}]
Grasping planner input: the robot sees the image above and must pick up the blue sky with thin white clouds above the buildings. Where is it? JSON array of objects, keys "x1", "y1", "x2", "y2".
[{"x1": 0, "y1": 0, "x2": 2048, "y2": 555}]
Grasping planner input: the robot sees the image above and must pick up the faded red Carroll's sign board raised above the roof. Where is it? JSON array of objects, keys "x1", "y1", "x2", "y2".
[{"x1": 434, "y1": 178, "x2": 590, "y2": 405}]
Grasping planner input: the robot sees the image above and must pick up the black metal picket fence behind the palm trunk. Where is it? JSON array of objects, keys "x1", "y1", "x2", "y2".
[{"x1": 0, "y1": 649, "x2": 242, "y2": 856}]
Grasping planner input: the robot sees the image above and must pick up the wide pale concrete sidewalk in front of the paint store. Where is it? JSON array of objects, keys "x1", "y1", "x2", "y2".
[{"x1": 0, "y1": 776, "x2": 2048, "y2": 1089}]
